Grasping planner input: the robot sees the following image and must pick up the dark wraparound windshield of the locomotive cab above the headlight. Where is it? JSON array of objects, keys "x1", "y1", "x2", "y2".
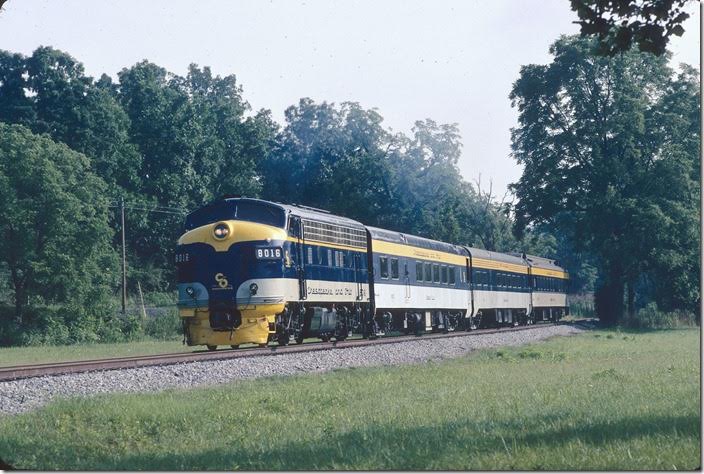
[{"x1": 186, "y1": 199, "x2": 286, "y2": 230}]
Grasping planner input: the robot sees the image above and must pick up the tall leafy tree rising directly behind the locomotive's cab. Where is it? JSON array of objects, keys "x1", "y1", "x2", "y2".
[{"x1": 116, "y1": 61, "x2": 276, "y2": 289}]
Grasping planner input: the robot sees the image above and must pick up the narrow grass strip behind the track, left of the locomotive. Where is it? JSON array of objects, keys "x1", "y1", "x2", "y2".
[{"x1": 0, "y1": 338, "x2": 187, "y2": 367}]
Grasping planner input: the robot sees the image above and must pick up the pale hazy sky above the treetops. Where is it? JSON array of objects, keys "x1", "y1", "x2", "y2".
[{"x1": 0, "y1": 0, "x2": 699, "y2": 195}]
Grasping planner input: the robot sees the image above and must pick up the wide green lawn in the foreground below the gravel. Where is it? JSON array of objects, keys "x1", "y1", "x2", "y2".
[{"x1": 0, "y1": 330, "x2": 701, "y2": 470}]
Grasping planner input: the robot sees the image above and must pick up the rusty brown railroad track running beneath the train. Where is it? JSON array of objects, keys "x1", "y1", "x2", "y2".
[{"x1": 0, "y1": 321, "x2": 579, "y2": 382}]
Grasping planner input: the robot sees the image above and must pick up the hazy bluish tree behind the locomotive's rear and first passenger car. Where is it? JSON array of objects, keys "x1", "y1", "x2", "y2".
[{"x1": 263, "y1": 98, "x2": 394, "y2": 223}]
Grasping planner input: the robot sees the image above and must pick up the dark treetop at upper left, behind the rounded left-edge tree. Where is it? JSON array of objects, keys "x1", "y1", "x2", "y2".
[{"x1": 0, "y1": 47, "x2": 141, "y2": 191}]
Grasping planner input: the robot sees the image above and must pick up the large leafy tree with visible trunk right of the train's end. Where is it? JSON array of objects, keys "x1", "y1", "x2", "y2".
[{"x1": 510, "y1": 37, "x2": 699, "y2": 322}]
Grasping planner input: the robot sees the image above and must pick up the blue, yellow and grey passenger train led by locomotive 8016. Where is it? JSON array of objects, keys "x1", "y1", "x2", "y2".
[{"x1": 175, "y1": 198, "x2": 569, "y2": 350}]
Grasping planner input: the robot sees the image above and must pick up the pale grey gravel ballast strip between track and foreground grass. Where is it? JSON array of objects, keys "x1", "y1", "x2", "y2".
[{"x1": 0, "y1": 325, "x2": 582, "y2": 415}]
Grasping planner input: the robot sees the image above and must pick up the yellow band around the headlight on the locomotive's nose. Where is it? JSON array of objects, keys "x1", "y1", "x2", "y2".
[{"x1": 178, "y1": 221, "x2": 287, "y2": 252}]
